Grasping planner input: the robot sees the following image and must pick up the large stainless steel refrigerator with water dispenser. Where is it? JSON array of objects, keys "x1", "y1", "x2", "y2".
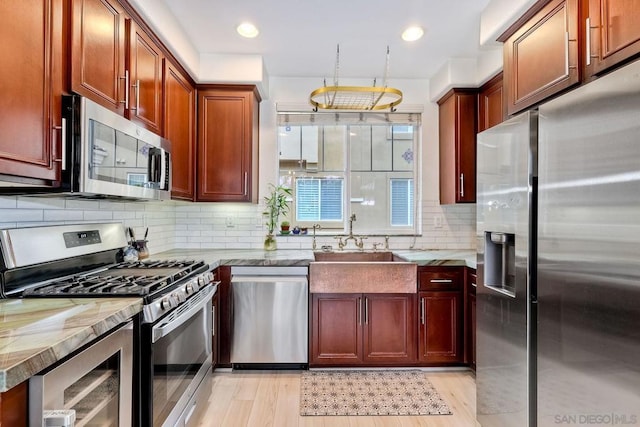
[{"x1": 476, "y1": 57, "x2": 640, "y2": 427}]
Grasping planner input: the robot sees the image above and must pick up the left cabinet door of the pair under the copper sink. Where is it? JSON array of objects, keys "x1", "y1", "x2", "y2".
[{"x1": 309, "y1": 294, "x2": 364, "y2": 365}]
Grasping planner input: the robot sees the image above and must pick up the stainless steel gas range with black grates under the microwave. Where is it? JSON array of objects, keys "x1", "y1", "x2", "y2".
[{"x1": 0, "y1": 223, "x2": 218, "y2": 427}]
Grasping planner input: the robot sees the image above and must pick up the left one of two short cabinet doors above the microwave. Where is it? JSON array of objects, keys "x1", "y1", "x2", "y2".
[{"x1": 71, "y1": 0, "x2": 128, "y2": 115}]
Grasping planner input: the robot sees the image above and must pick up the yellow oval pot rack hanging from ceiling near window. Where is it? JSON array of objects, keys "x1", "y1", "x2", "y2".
[{"x1": 309, "y1": 45, "x2": 402, "y2": 112}]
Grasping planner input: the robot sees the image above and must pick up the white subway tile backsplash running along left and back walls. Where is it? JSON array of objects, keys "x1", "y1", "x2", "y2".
[{"x1": 0, "y1": 196, "x2": 476, "y2": 254}]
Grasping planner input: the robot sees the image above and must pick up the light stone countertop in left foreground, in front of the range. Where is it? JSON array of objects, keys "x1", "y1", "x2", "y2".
[{"x1": 0, "y1": 298, "x2": 142, "y2": 392}]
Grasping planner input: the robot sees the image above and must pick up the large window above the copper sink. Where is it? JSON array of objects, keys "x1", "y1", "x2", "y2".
[{"x1": 278, "y1": 112, "x2": 421, "y2": 235}]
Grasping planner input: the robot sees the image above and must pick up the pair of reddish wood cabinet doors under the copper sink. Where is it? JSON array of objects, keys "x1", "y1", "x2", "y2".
[{"x1": 309, "y1": 294, "x2": 416, "y2": 366}]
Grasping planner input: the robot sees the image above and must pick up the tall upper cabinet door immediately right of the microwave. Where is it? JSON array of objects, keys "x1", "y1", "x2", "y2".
[{"x1": 163, "y1": 59, "x2": 196, "y2": 200}]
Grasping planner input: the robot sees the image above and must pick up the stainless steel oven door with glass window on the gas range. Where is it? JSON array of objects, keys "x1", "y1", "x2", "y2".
[{"x1": 141, "y1": 286, "x2": 216, "y2": 426}]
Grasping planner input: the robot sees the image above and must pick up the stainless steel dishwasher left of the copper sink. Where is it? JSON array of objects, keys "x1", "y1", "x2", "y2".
[{"x1": 231, "y1": 266, "x2": 309, "y2": 369}]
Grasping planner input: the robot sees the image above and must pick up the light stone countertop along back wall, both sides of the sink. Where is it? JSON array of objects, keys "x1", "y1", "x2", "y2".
[{"x1": 152, "y1": 249, "x2": 476, "y2": 268}]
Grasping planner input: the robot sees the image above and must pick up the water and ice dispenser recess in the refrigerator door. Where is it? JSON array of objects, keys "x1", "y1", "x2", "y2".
[{"x1": 484, "y1": 231, "x2": 516, "y2": 297}]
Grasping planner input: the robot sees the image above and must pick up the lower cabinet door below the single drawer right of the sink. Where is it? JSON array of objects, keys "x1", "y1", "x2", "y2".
[{"x1": 419, "y1": 292, "x2": 463, "y2": 364}]
